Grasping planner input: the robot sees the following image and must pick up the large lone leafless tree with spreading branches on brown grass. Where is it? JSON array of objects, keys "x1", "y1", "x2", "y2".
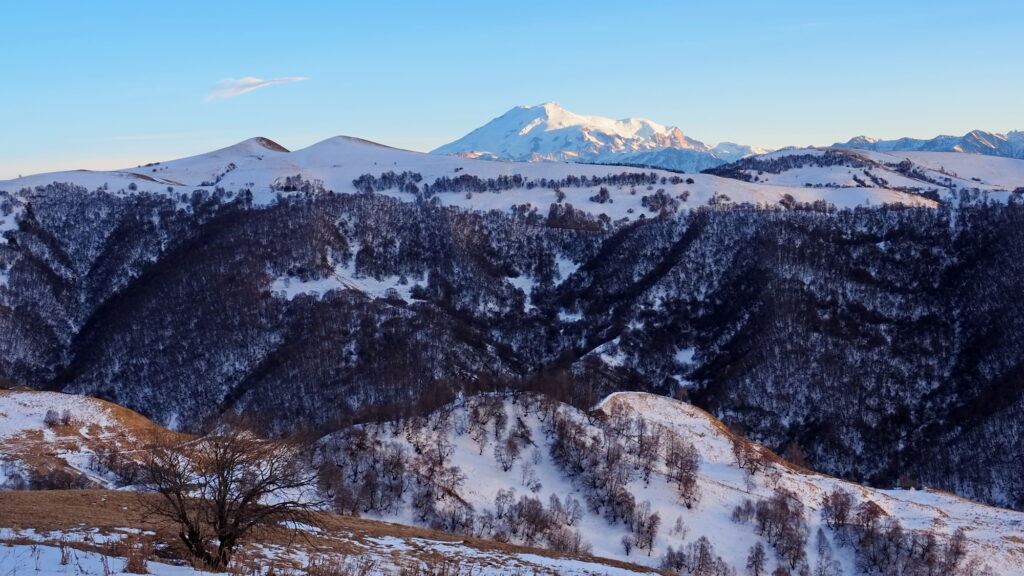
[{"x1": 142, "y1": 425, "x2": 319, "y2": 571}]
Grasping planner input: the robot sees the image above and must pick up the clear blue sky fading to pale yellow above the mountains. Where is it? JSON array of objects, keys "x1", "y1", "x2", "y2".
[{"x1": 0, "y1": 0, "x2": 1024, "y2": 179}]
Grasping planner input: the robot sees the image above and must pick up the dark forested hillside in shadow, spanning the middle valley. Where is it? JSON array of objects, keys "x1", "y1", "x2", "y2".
[{"x1": 0, "y1": 144, "x2": 1024, "y2": 508}]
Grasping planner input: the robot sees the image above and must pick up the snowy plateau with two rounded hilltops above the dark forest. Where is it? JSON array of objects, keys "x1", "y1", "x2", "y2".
[{"x1": 0, "y1": 134, "x2": 932, "y2": 219}]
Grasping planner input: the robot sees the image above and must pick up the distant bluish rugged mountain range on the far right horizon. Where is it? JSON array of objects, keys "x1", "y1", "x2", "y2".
[{"x1": 833, "y1": 130, "x2": 1024, "y2": 158}]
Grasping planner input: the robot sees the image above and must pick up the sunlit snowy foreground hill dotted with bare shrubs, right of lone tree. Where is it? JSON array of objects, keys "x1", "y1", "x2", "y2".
[{"x1": 323, "y1": 393, "x2": 1024, "y2": 574}]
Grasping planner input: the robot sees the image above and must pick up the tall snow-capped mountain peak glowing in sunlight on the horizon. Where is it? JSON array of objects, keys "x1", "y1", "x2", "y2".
[{"x1": 433, "y1": 102, "x2": 765, "y2": 171}]
